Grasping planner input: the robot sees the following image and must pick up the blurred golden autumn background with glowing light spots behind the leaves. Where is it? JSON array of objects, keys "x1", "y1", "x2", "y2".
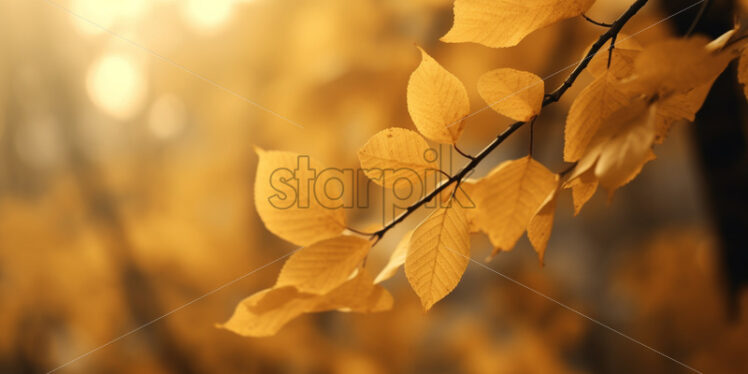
[{"x1": 0, "y1": 0, "x2": 748, "y2": 373}]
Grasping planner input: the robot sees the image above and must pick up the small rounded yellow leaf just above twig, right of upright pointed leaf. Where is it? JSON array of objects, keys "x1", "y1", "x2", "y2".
[{"x1": 478, "y1": 68, "x2": 545, "y2": 122}]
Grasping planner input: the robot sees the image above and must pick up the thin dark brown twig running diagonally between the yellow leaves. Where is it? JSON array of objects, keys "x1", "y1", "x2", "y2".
[{"x1": 372, "y1": 0, "x2": 648, "y2": 240}]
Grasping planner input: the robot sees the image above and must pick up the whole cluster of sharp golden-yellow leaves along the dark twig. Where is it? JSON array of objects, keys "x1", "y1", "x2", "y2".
[{"x1": 222, "y1": 0, "x2": 748, "y2": 336}]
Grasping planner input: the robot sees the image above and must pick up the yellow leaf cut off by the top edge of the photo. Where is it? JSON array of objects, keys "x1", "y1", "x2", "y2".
[{"x1": 441, "y1": 0, "x2": 595, "y2": 48}]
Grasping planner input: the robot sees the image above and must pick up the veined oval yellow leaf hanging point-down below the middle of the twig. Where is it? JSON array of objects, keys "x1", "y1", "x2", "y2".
[{"x1": 405, "y1": 202, "x2": 470, "y2": 310}]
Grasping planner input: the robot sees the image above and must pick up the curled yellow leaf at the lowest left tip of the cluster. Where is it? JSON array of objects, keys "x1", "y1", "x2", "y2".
[{"x1": 218, "y1": 287, "x2": 318, "y2": 337}]
